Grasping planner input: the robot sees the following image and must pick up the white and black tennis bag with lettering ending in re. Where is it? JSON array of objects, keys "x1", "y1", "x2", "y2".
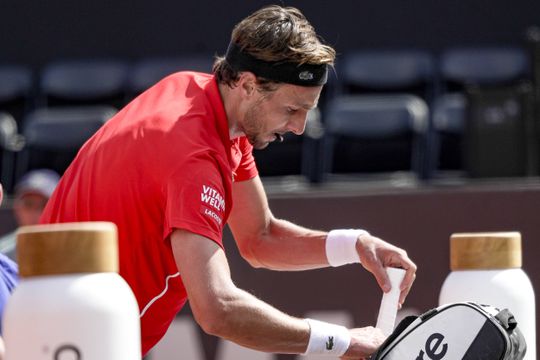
[{"x1": 371, "y1": 302, "x2": 527, "y2": 360}]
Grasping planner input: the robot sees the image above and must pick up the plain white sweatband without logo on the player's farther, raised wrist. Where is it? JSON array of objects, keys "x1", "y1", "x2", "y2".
[{"x1": 326, "y1": 229, "x2": 369, "y2": 267}]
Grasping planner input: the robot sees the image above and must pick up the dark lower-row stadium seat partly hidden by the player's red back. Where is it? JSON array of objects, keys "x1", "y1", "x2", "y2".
[{"x1": 16, "y1": 106, "x2": 116, "y2": 179}]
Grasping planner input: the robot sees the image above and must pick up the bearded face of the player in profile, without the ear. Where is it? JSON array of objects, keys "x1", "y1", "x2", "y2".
[{"x1": 239, "y1": 84, "x2": 322, "y2": 149}]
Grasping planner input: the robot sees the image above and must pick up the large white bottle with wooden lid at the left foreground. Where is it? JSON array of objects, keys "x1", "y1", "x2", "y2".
[{"x1": 3, "y1": 222, "x2": 141, "y2": 360}]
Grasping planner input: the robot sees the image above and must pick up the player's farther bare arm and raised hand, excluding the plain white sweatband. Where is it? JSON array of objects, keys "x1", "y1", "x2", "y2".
[{"x1": 228, "y1": 177, "x2": 416, "y2": 304}]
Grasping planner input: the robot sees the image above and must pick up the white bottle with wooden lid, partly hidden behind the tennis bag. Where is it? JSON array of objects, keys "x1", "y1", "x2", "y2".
[{"x1": 439, "y1": 232, "x2": 536, "y2": 360}]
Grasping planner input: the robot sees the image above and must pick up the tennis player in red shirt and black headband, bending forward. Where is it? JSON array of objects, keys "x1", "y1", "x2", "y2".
[{"x1": 42, "y1": 6, "x2": 416, "y2": 359}]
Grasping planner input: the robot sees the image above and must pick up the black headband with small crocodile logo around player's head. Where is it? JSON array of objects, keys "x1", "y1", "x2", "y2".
[{"x1": 225, "y1": 42, "x2": 328, "y2": 86}]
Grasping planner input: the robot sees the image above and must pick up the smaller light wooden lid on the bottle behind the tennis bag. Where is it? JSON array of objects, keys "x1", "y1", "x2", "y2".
[{"x1": 450, "y1": 232, "x2": 521, "y2": 270}]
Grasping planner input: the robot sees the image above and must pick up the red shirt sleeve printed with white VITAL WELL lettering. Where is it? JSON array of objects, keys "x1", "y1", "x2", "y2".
[{"x1": 164, "y1": 154, "x2": 226, "y2": 247}]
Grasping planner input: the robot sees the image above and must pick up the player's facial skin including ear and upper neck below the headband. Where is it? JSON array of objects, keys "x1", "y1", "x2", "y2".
[{"x1": 220, "y1": 72, "x2": 322, "y2": 149}]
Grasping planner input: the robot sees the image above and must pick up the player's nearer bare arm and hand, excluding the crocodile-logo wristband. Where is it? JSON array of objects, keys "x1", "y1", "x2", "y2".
[{"x1": 171, "y1": 230, "x2": 384, "y2": 359}]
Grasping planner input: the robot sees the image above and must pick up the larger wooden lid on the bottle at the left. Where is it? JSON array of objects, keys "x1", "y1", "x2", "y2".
[{"x1": 17, "y1": 222, "x2": 118, "y2": 277}]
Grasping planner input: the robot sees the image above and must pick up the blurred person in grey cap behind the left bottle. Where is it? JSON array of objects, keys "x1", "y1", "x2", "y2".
[{"x1": 0, "y1": 169, "x2": 60, "y2": 261}]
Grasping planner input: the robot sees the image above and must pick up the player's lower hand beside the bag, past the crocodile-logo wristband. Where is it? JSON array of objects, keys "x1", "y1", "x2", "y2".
[{"x1": 341, "y1": 326, "x2": 386, "y2": 360}]
